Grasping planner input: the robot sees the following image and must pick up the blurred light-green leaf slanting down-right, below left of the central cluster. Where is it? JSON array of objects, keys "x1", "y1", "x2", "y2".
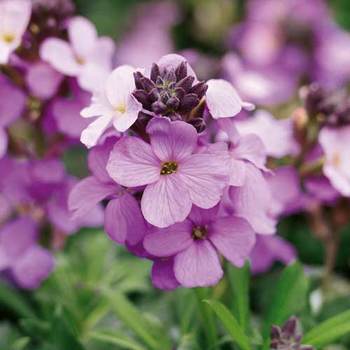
[{"x1": 107, "y1": 291, "x2": 171, "y2": 350}]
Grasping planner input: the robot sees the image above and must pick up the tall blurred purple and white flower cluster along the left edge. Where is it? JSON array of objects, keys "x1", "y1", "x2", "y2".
[{"x1": 0, "y1": 0, "x2": 114, "y2": 289}]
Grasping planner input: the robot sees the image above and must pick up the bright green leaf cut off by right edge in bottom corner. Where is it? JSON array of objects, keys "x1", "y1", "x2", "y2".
[{"x1": 303, "y1": 311, "x2": 350, "y2": 348}]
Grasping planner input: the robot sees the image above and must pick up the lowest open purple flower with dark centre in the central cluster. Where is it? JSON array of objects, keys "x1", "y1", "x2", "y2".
[{"x1": 144, "y1": 207, "x2": 255, "y2": 287}]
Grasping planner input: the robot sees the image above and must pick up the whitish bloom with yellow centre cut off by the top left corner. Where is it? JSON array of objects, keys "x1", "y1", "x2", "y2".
[{"x1": 0, "y1": 0, "x2": 31, "y2": 64}]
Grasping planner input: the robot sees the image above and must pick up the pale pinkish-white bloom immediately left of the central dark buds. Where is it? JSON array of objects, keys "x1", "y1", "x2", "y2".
[{"x1": 81, "y1": 66, "x2": 142, "y2": 147}]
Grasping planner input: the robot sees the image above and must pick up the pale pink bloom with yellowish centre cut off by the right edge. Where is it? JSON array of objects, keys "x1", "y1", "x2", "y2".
[{"x1": 319, "y1": 126, "x2": 350, "y2": 197}]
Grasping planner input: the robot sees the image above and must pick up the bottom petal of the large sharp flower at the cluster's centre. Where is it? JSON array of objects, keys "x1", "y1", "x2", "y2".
[{"x1": 141, "y1": 174, "x2": 192, "y2": 227}]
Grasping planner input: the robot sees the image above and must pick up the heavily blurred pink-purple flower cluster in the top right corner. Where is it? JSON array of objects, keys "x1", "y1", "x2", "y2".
[{"x1": 222, "y1": 0, "x2": 350, "y2": 106}]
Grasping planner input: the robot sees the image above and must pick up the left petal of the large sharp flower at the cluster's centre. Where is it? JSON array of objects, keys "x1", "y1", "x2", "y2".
[{"x1": 107, "y1": 136, "x2": 160, "y2": 187}]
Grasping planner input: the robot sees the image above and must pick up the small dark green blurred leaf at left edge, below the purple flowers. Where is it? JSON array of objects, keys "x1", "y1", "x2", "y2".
[{"x1": 0, "y1": 283, "x2": 35, "y2": 317}]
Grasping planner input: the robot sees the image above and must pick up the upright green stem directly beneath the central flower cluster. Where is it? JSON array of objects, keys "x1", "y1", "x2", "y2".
[{"x1": 194, "y1": 288, "x2": 218, "y2": 350}]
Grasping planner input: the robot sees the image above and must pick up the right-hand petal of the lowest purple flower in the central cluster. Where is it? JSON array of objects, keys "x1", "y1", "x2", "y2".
[{"x1": 209, "y1": 217, "x2": 255, "y2": 267}]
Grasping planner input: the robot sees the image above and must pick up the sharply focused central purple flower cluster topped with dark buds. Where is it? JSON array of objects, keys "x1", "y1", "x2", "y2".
[{"x1": 69, "y1": 54, "x2": 275, "y2": 289}]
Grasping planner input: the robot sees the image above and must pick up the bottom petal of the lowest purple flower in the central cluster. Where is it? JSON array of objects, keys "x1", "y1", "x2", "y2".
[{"x1": 174, "y1": 240, "x2": 223, "y2": 288}]
